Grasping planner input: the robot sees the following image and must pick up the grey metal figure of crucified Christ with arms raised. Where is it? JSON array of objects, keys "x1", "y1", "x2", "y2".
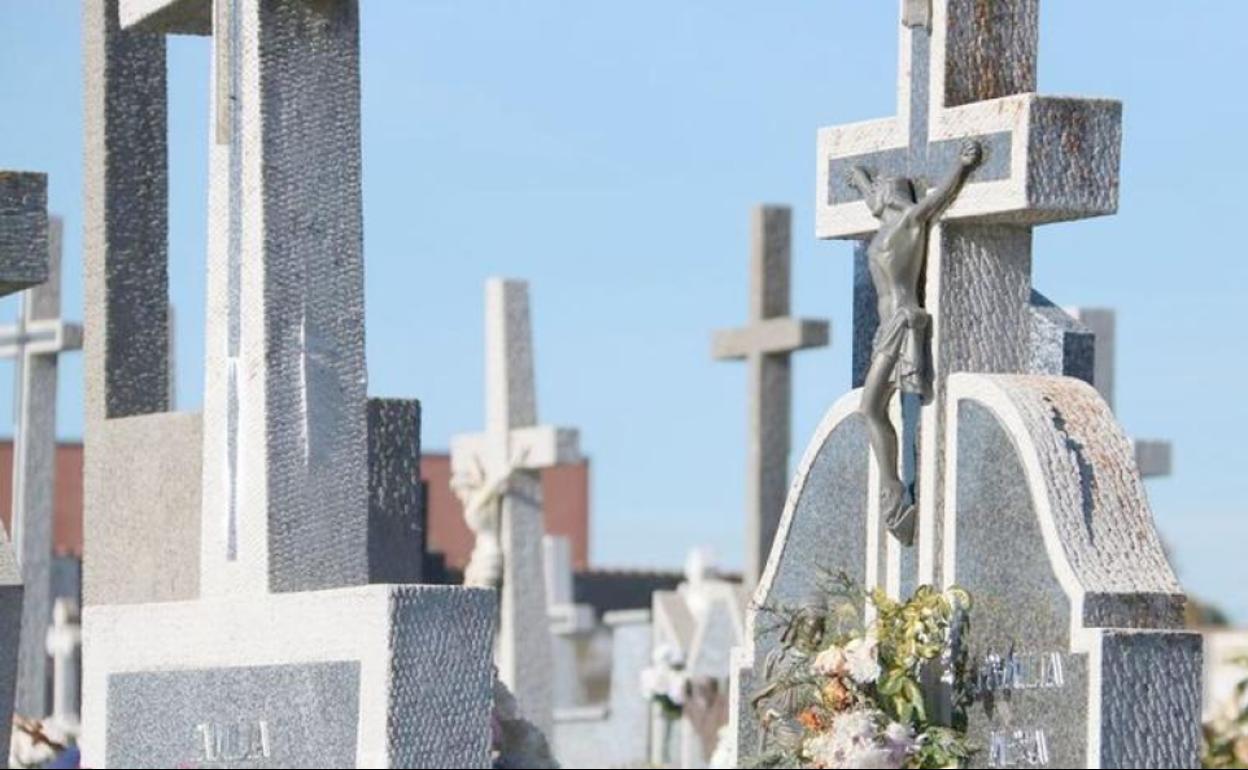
[{"x1": 849, "y1": 140, "x2": 982, "y2": 545}]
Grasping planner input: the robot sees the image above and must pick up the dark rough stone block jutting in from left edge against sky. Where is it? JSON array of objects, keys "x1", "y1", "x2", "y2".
[{"x1": 0, "y1": 171, "x2": 49, "y2": 296}]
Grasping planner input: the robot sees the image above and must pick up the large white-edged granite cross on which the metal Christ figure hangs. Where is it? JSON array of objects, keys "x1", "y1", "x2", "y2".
[{"x1": 815, "y1": 0, "x2": 1122, "y2": 593}]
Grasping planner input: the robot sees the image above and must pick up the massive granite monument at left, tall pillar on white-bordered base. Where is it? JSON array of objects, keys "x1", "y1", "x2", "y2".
[{"x1": 81, "y1": 0, "x2": 494, "y2": 768}]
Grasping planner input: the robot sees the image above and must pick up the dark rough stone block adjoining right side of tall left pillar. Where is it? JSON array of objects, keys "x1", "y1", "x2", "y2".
[{"x1": 368, "y1": 398, "x2": 426, "y2": 583}]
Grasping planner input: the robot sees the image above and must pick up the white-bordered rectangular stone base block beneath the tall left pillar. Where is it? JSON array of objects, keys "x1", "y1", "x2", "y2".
[{"x1": 82, "y1": 585, "x2": 494, "y2": 768}]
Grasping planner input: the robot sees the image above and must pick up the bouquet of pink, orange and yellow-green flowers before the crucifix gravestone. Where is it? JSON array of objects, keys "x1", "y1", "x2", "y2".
[{"x1": 749, "y1": 574, "x2": 973, "y2": 768}]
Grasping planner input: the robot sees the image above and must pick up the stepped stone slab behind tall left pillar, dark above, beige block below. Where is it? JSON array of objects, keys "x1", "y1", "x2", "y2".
[{"x1": 82, "y1": 0, "x2": 184, "y2": 603}]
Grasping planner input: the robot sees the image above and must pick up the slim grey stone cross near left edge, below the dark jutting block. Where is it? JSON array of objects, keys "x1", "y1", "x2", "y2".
[{"x1": 0, "y1": 218, "x2": 82, "y2": 719}]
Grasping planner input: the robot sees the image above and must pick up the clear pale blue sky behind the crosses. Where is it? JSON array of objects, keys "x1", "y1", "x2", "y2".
[{"x1": 0, "y1": 0, "x2": 1248, "y2": 620}]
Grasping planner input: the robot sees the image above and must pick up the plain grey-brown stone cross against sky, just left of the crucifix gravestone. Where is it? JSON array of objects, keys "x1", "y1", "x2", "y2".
[{"x1": 711, "y1": 206, "x2": 829, "y2": 585}]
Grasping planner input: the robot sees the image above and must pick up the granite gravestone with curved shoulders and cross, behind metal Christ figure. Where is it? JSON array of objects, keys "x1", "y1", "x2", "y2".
[{"x1": 733, "y1": 0, "x2": 1201, "y2": 766}]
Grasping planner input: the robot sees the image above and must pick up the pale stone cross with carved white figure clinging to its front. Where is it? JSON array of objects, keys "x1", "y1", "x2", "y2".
[{"x1": 451, "y1": 278, "x2": 580, "y2": 735}]
